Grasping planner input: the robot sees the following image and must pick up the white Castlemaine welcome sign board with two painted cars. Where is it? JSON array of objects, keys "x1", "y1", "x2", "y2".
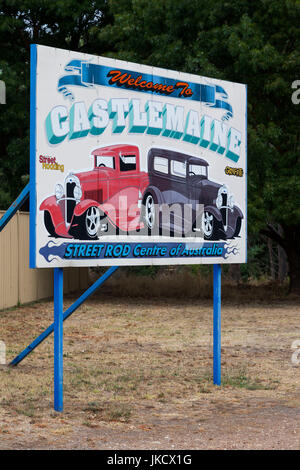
[{"x1": 30, "y1": 45, "x2": 247, "y2": 267}]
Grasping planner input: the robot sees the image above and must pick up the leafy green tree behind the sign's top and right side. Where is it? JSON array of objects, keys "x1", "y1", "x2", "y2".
[{"x1": 99, "y1": 0, "x2": 300, "y2": 294}]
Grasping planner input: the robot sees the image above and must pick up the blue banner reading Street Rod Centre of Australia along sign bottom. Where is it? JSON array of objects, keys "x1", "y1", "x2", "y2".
[{"x1": 40, "y1": 241, "x2": 238, "y2": 263}]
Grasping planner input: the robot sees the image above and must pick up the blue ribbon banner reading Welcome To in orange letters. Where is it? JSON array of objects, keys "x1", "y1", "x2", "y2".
[{"x1": 57, "y1": 60, "x2": 233, "y2": 120}]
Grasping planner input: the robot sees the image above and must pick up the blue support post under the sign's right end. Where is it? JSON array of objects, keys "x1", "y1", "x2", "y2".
[{"x1": 213, "y1": 264, "x2": 221, "y2": 385}]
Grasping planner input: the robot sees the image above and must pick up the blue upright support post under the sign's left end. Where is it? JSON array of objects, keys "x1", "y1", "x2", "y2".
[{"x1": 54, "y1": 268, "x2": 63, "y2": 411}]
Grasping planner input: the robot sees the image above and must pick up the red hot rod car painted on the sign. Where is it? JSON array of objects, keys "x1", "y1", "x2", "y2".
[{"x1": 40, "y1": 144, "x2": 149, "y2": 240}]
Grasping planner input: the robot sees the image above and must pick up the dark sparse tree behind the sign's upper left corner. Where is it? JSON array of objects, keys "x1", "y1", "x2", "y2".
[{"x1": 0, "y1": 0, "x2": 112, "y2": 209}]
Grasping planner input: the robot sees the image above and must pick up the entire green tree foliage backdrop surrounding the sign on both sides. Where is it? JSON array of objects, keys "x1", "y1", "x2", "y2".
[{"x1": 0, "y1": 0, "x2": 300, "y2": 292}]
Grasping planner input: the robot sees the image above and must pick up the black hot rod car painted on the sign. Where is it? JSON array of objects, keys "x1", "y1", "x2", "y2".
[{"x1": 142, "y1": 148, "x2": 244, "y2": 240}]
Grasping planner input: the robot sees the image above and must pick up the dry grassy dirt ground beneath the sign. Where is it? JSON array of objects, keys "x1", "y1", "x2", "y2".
[{"x1": 0, "y1": 295, "x2": 300, "y2": 450}]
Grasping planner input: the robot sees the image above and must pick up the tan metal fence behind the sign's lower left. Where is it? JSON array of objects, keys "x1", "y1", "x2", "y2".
[{"x1": 0, "y1": 211, "x2": 89, "y2": 310}]
